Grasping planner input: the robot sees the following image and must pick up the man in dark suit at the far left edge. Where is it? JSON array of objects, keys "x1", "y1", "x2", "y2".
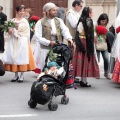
[{"x1": 0, "y1": 6, "x2": 7, "y2": 53}]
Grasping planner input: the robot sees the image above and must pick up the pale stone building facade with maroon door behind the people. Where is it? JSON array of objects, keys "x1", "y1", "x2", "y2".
[{"x1": 0, "y1": 0, "x2": 117, "y2": 25}]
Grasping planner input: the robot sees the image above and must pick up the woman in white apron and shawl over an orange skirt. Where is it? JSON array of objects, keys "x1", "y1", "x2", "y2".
[{"x1": 2, "y1": 5, "x2": 36, "y2": 83}]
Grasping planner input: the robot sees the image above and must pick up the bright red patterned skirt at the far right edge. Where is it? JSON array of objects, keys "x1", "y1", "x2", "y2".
[{"x1": 112, "y1": 59, "x2": 120, "y2": 83}]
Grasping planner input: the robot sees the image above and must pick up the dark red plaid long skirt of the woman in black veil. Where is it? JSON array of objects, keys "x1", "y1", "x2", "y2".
[{"x1": 73, "y1": 39, "x2": 100, "y2": 77}]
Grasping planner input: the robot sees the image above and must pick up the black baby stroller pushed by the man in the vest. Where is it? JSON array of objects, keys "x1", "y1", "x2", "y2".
[{"x1": 28, "y1": 44, "x2": 74, "y2": 111}]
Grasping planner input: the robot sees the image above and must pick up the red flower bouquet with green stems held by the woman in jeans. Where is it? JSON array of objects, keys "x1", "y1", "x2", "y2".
[{"x1": 96, "y1": 25, "x2": 107, "y2": 42}]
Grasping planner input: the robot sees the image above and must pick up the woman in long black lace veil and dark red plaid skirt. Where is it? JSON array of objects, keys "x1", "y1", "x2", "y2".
[{"x1": 73, "y1": 7, "x2": 99, "y2": 87}]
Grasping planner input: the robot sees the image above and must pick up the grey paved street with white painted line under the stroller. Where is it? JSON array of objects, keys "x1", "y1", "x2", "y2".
[{"x1": 0, "y1": 39, "x2": 120, "y2": 120}]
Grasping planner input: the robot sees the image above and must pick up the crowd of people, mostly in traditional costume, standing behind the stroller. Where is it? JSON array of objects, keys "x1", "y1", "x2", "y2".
[{"x1": 0, "y1": 0, "x2": 120, "y2": 87}]
